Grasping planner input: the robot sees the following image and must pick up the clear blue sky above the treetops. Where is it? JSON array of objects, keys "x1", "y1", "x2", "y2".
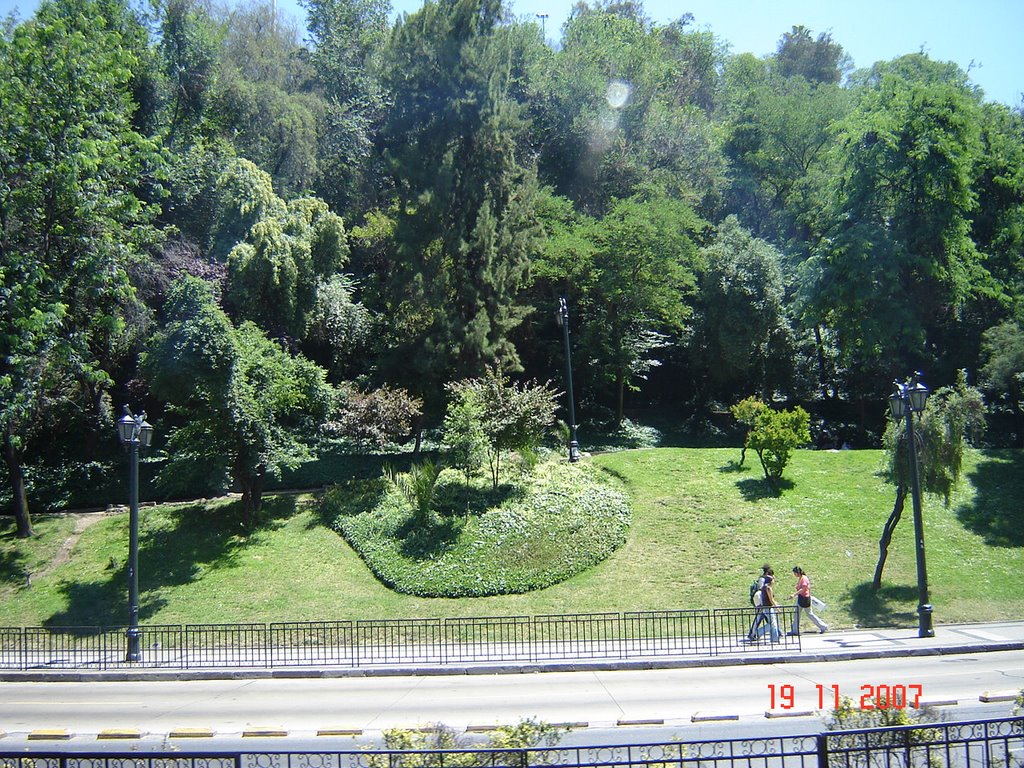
[{"x1": 0, "y1": 0, "x2": 1024, "y2": 106}]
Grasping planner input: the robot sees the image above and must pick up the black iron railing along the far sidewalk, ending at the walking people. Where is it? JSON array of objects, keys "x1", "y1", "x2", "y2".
[{"x1": 0, "y1": 608, "x2": 800, "y2": 670}]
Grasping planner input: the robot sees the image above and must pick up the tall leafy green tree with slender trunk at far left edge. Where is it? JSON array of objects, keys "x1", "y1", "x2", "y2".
[{"x1": 0, "y1": 0, "x2": 159, "y2": 537}]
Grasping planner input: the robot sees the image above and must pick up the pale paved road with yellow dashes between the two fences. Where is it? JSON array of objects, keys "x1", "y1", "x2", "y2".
[{"x1": 0, "y1": 623, "x2": 1024, "y2": 750}]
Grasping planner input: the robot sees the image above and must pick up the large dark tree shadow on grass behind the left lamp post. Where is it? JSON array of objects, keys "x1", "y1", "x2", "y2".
[{"x1": 43, "y1": 497, "x2": 297, "y2": 628}]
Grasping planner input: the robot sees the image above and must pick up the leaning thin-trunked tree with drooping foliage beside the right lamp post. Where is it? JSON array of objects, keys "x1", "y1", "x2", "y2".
[{"x1": 871, "y1": 371, "x2": 985, "y2": 591}]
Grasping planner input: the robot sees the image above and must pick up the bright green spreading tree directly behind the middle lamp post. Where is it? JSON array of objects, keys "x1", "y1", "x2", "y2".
[{"x1": 534, "y1": 190, "x2": 706, "y2": 421}]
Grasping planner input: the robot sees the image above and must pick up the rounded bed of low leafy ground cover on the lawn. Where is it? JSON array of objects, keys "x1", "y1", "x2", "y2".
[{"x1": 323, "y1": 460, "x2": 630, "y2": 597}]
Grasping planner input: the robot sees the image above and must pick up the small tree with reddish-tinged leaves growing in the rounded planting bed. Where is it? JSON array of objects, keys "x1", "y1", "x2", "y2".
[{"x1": 450, "y1": 366, "x2": 559, "y2": 490}]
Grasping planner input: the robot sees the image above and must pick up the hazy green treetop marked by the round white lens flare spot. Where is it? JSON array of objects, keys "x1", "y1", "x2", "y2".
[{"x1": 530, "y1": 3, "x2": 726, "y2": 215}]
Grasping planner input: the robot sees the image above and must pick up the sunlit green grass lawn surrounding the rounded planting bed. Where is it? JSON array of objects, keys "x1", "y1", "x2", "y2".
[{"x1": 0, "y1": 449, "x2": 1024, "y2": 628}]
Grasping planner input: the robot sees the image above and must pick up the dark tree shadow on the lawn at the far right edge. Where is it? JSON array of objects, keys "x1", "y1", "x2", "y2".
[{"x1": 956, "y1": 451, "x2": 1024, "y2": 547}]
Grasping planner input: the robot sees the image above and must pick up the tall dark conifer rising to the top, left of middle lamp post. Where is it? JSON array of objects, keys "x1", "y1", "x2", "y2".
[{"x1": 372, "y1": 0, "x2": 539, "y2": 413}]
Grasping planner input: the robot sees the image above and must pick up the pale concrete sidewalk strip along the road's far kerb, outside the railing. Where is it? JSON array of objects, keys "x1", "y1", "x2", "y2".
[{"x1": 0, "y1": 621, "x2": 1024, "y2": 682}]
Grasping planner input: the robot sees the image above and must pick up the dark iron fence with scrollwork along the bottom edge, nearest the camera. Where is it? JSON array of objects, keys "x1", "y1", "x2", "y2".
[{"x1": 0, "y1": 718, "x2": 1024, "y2": 768}]
